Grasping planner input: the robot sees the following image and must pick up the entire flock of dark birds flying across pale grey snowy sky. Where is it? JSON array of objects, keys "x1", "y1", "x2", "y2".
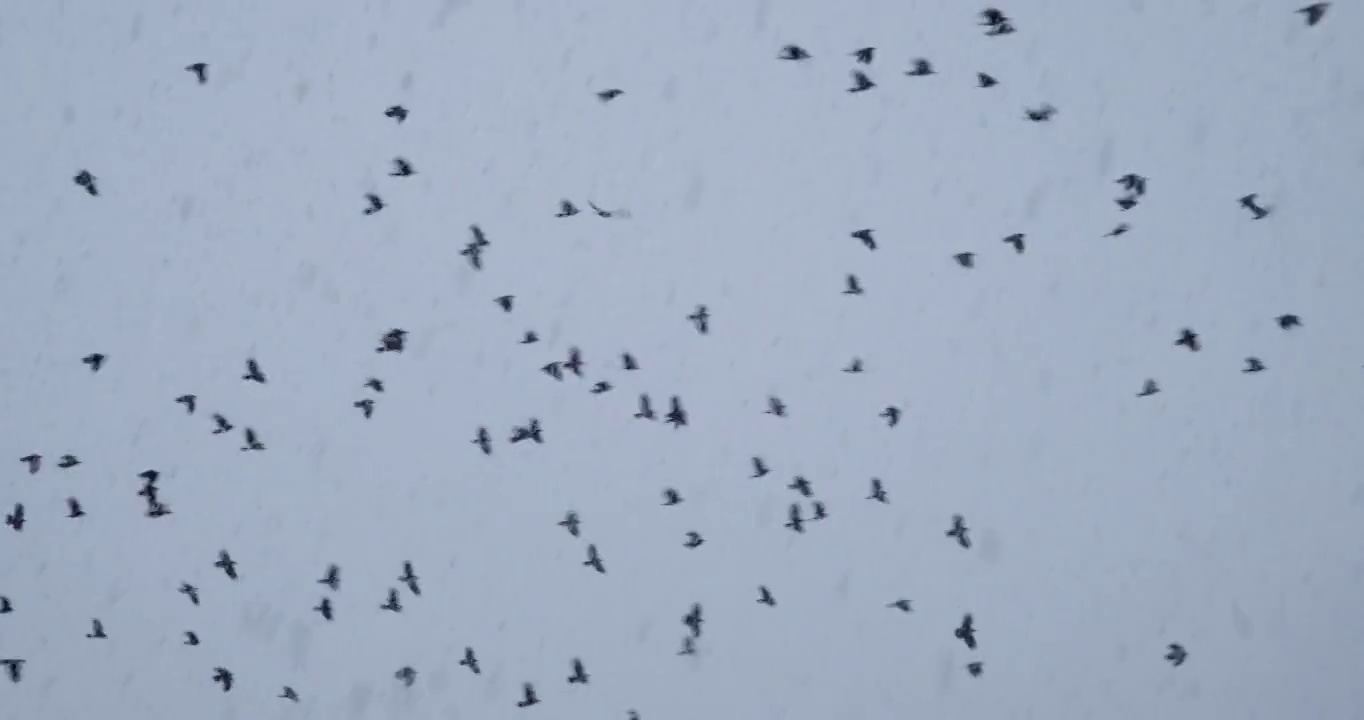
[{"x1": 0, "y1": 3, "x2": 1329, "y2": 719}]
